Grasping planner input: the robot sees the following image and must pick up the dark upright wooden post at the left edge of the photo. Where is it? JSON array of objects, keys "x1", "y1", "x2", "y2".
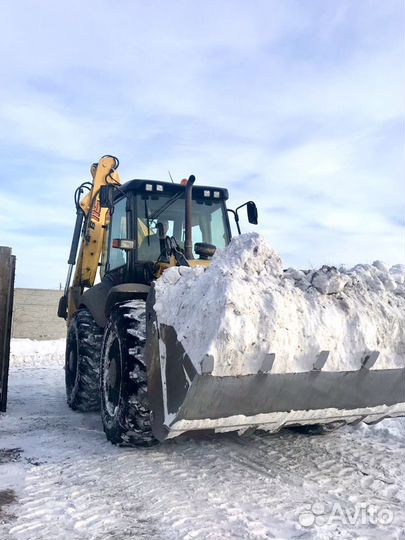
[{"x1": 0, "y1": 246, "x2": 15, "y2": 412}]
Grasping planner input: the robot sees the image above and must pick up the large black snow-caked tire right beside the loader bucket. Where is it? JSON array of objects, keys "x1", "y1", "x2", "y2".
[{"x1": 100, "y1": 300, "x2": 157, "y2": 446}]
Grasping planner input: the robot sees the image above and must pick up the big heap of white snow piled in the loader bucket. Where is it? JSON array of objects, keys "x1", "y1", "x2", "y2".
[{"x1": 154, "y1": 233, "x2": 405, "y2": 376}]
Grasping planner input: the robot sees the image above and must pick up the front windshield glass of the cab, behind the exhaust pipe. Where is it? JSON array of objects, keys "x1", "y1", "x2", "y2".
[{"x1": 137, "y1": 193, "x2": 230, "y2": 261}]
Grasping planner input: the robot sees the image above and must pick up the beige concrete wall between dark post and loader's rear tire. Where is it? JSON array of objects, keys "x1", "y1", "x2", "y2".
[{"x1": 11, "y1": 289, "x2": 66, "y2": 339}]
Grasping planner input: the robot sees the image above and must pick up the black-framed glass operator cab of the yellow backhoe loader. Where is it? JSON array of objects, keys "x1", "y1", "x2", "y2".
[{"x1": 100, "y1": 180, "x2": 231, "y2": 277}]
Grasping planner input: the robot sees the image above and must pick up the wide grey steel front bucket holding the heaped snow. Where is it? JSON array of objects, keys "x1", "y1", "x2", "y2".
[{"x1": 145, "y1": 293, "x2": 405, "y2": 441}]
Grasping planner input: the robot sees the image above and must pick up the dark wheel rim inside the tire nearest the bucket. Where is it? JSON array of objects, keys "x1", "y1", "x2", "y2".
[{"x1": 103, "y1": 338, "x2": 122, "y2": 416}]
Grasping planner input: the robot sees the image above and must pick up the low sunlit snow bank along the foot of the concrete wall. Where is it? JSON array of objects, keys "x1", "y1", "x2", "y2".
[{"x1": 10, "y1": 338, "x2": 66, "y2": 369}]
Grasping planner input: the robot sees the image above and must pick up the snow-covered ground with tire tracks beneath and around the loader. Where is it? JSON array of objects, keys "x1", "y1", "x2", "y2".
[{"x1": 0, "y1": 340, "x2": 405, "y2": 540}]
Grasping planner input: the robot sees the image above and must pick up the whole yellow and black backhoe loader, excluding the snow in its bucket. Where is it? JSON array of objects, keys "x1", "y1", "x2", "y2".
[{"x1": 58, "y1": 155, "x2": 405, "y2": 446}]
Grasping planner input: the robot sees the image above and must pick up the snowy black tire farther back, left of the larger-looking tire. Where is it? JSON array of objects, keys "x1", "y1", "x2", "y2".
[{"x1": 65, "y1": 309, "x2": 103, "y2": 412}]
